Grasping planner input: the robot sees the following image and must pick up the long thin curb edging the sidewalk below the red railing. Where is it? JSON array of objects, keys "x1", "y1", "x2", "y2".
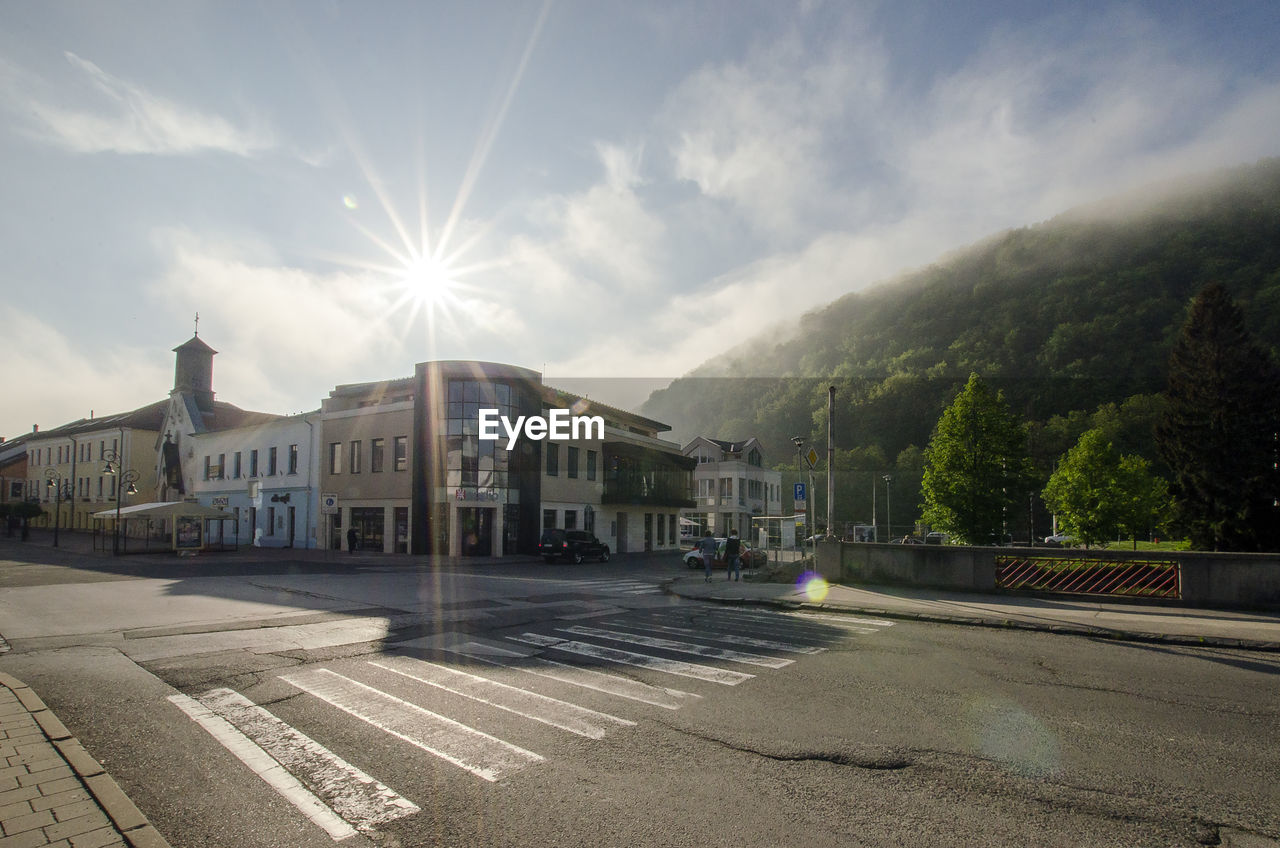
[{"x1": 663, "y1": 584, "x2": 1280, "y2": 653}]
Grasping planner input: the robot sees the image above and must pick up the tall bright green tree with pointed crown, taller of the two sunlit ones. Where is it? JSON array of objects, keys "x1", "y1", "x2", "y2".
[{"x1": 920, "y1": 374, "x2": 1032, "y2": 544}]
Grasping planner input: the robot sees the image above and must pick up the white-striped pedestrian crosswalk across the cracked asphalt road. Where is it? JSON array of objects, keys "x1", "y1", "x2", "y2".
[{"x1": 169, "y1": 607, "x2": 892, "y2": 840}]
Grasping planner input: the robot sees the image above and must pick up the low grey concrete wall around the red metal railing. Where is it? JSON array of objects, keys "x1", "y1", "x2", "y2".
[{"x1": 817, "y1": 542, "x2": 1280, "y2": 610}]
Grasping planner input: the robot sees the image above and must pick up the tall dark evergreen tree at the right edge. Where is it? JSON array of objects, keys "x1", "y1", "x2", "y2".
[{"x1": 1156, "y1": 283, "x2": 1280, "y2": 551}]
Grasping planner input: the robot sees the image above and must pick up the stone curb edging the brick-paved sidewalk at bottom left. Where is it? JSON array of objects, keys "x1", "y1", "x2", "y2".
[{"x1": 0, "y1": 671, "x2": 170, "y2": 848}]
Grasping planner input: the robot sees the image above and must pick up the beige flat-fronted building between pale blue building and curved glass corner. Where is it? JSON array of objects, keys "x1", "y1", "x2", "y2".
[{"x1": 317, "y1": 377, "x2": 416, "y2": 553}]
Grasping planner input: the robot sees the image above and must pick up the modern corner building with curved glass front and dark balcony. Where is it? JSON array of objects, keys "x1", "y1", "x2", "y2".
[{"x1": 410, "y1": 361, "x2": 694, "y2": 556}]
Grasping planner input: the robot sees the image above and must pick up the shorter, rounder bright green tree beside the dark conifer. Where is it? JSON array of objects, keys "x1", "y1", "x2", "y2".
[{"x1": 1043, "y1": 428, "x2": 1169, "y2": 547}]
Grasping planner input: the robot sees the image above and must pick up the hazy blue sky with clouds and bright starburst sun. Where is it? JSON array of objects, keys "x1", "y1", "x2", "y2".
[{"x1": 0, "y1": 0, "x2": 1280, "y2": 438}]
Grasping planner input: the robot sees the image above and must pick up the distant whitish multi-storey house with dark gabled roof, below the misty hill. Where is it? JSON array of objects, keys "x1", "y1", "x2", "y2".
[{"x1": 682, "y1": 436, "x2": 782, "y2": 537}]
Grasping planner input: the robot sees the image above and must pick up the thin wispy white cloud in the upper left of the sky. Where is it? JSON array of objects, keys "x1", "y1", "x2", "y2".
[{"x1": 0, "y1": 53, "x2": 275, "y2": 156}]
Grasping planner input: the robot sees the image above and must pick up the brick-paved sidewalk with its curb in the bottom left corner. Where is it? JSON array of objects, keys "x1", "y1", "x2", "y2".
[{"x1": 0, "y1": 673, "x2": 169, "y2": 848}]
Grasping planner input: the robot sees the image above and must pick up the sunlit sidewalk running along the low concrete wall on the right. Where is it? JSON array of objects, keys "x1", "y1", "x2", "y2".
[{"x1": 667, "y1": 571, "x2": 1280, "y2": 651}]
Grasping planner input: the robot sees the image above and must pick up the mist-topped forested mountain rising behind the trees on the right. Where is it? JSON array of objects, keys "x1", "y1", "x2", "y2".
[{"x1": 643, "y1": 159, "x2": 1280, "y2": 526}]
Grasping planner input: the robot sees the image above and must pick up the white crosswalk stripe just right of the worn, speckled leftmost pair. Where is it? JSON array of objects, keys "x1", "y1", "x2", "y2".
[{"x1": 280, "y1": 669, "x2": 545, "y2": 783}]
